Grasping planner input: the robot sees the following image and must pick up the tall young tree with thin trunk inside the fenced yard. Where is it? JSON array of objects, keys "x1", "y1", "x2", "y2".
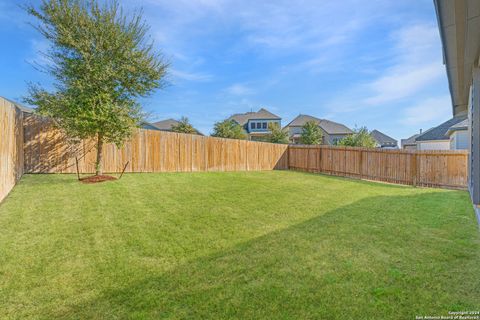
[{"x1": 25, "y1": 0, "x2": 168, "y2": 175}]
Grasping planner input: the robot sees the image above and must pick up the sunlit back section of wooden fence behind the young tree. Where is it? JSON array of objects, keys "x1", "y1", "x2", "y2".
[{"x1": 24, "y1": 116, "x2": 288, "y2": 173}]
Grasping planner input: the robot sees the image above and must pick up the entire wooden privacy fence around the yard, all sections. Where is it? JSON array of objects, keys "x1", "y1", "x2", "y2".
[{"x1": 4, "y1": 113, "x2": 468, "y2": 190}]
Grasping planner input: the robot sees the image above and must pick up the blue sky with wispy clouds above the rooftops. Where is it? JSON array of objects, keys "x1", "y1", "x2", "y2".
[{"x1": 0, "y1": 0, "x2": 451, "y2": 139}]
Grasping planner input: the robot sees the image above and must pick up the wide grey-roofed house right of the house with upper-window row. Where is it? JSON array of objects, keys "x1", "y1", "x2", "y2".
[{"x1": 284, "y1": 114, "x2": 353, "y2": 145}]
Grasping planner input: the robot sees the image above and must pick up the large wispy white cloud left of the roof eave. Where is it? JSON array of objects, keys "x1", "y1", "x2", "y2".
[{"x1": 328, "y1": 24, "x2": 449, "y2": 114}]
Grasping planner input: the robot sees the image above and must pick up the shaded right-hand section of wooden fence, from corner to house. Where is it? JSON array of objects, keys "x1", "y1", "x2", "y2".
[{"x1": 288, "y1": 145, "x2": 468, "y2": 189}]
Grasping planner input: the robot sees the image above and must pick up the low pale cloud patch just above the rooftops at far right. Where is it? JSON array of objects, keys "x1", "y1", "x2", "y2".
[{"x1": 399, "y1": 95, "x2": 452, "y2": 125}]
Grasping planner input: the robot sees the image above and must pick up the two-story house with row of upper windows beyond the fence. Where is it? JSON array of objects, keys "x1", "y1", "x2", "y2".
[{"x1": 228, "y1": 108, "x2": 282, "y2": 141}]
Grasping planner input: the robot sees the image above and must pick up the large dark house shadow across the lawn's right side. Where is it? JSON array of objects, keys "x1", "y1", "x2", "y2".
[{"x1": 50, "y1": 191, "x2": 480, "y2": 319}]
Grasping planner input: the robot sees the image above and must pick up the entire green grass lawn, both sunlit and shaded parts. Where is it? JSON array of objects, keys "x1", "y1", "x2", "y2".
[{"x1": 0, "y1": 171, "x2": 480, "y2": 320}]
